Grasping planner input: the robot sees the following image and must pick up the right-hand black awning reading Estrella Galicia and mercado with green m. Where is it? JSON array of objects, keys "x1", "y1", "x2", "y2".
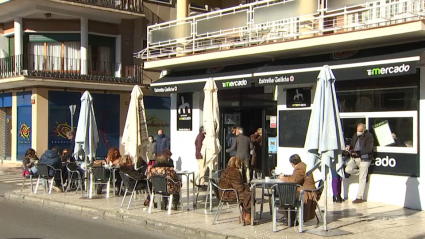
[{"x1": 253, "y1": 49, "x2": 424, "y2": 86}]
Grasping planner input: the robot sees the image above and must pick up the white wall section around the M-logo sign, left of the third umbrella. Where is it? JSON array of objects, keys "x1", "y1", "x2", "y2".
[{"x1": 170, "y1": 92, "x2": 204, "y2": 180}]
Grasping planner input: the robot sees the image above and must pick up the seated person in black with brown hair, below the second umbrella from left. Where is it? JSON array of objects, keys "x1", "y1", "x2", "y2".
[{"x1": 120, "y1": 154, "x2": 152, "y2": 206}]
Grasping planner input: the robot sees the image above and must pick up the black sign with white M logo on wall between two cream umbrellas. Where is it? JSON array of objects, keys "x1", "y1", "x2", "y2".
[{"x1": 177, "y1": 93, "x2": 193, "y2": 131}]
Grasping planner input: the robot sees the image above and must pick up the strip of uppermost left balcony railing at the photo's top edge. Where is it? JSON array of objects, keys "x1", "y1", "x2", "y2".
[{"x1": 63, "y1": 0, "x2": 143, "y2": 13}]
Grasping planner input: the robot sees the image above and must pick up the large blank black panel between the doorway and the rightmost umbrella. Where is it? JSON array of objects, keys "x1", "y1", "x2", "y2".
[{"x1": 278, "y1": 110, "x2": 311, "y2": 148}]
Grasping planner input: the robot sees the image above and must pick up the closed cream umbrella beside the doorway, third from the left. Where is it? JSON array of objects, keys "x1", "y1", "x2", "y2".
[{"x1": 201, "y1": 79, "x2": 221, "y2": 175}]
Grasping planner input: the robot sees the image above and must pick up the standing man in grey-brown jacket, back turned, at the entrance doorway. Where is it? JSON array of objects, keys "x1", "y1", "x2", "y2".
[{"x1": 226, "y1": 127, "x2": 254, "y2": 183}]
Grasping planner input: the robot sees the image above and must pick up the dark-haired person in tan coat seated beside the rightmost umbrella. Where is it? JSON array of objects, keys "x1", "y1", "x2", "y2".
[{"x1": 280, "y1": 154, "x2": 318, "y2": 225}]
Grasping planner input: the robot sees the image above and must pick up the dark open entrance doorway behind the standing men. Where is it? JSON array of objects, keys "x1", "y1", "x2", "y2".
[{"x1": 218, "y1": 87, "x2": 277, "y2": 177}]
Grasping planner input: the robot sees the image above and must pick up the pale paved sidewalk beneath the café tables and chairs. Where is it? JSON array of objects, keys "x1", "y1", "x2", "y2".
[{"x1": 5, "y1": 181, "x2": 425, "y2": 239}]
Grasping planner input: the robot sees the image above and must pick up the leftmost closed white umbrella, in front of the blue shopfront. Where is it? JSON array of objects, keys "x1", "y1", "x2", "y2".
[{"x1": 74, "y1": 91, "x2": 99, "y2": 196}]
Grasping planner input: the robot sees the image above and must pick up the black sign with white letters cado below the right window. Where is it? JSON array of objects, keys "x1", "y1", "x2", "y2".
[{"x1": 369, "y1": 152, "x2": 419, "y2": 177}]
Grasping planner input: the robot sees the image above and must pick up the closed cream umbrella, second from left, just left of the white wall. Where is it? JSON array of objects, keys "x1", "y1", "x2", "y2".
[{"x1": 121, "y1": 85, "x2": 148, "y2": 168}]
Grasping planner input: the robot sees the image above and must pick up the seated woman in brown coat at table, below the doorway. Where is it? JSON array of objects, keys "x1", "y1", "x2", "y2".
[{"x1": 219, "y1": 156, "x2": 251, "y2": 224}]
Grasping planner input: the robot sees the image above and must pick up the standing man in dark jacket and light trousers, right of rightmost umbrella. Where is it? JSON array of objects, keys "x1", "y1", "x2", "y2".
[{"x1": 345, "y1": 123, "x2": 373, "y2": 203}]
